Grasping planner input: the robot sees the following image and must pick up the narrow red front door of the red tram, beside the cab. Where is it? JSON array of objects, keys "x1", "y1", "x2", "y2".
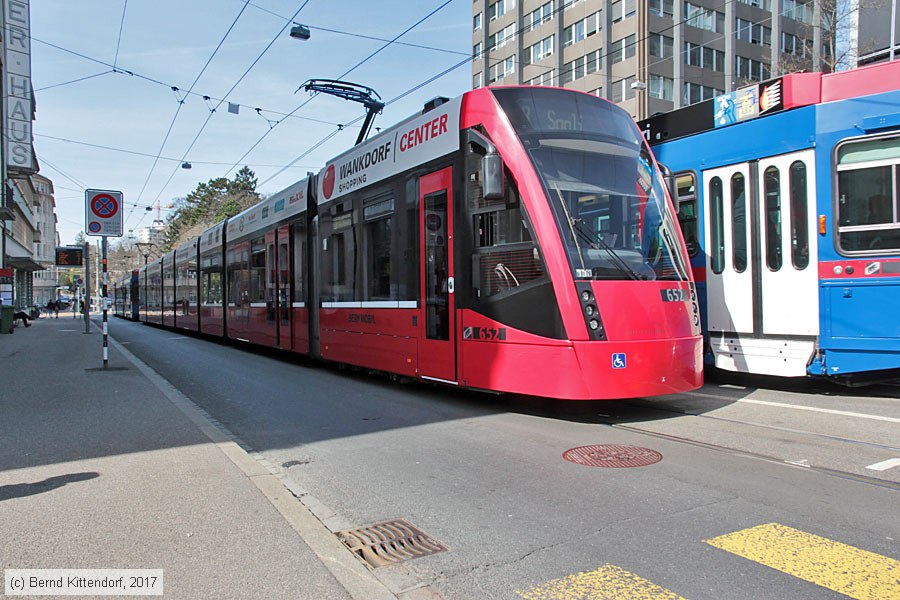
[{"x1": 419, "y1": 167, "x2": 456, "y2": 383}]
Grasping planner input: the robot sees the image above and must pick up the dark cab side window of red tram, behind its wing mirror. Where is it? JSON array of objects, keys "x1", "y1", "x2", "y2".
[{"x1": 466, "y1": 153, "x2": 546, "y2": 298}]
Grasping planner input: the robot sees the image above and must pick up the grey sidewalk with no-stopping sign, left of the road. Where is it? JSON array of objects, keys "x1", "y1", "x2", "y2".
[{"x1": 0, "y1": 314, "x2": 394, "y2": 600}]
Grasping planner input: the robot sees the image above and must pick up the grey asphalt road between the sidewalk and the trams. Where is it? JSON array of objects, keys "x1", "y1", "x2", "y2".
[{"x1": 110, "y1": 320, "x2": 900, "y2": 600}]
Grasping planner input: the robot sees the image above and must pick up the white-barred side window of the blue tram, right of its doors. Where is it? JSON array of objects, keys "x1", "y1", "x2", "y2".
[{"x1": 836, "y1": 134, "x2": 900, "y2": 253}]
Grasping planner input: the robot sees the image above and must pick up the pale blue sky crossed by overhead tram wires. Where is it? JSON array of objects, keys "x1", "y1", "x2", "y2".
[{"x1": 31, "y1": 0, "x2": 472, "y2": 244}]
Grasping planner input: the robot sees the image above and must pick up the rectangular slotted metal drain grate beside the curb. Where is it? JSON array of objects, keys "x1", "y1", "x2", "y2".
[{"x1": 337, "y1": 519, "x2": 447, "y2": 568}]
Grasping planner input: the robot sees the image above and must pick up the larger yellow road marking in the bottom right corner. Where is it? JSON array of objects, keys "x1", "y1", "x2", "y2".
[{"x1": 706, "y1": 523, "x2": 900, "y2": 600}]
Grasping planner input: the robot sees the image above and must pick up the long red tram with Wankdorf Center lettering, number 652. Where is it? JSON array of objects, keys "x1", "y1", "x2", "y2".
[{"x1": 118, "y1": 87, "x2": 703, "y2": 400}]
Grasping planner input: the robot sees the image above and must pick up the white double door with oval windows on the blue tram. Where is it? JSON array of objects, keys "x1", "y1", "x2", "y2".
[{"x1": 703, "y1": 150, "x2": 819, "y2": 376}]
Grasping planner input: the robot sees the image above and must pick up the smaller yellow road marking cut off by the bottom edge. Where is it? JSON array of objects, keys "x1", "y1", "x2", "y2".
[{"x1": 516, "y1": 565, "x2": 684, "y2": 600}]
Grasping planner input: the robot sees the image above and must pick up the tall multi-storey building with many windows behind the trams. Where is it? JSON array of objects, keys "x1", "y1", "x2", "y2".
[{"x1": 472, "y1": 0, "x2": 828, "y2": 119}]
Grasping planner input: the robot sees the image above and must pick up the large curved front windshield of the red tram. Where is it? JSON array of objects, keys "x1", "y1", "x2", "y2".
[{"x1": 493, "y1": 88, "x2": 688, "y2": 280}]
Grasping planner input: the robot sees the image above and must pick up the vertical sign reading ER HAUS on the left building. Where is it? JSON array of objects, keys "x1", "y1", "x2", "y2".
[{"x1": 3, "y1": 0, "x2": 34, "y2": 174}]
